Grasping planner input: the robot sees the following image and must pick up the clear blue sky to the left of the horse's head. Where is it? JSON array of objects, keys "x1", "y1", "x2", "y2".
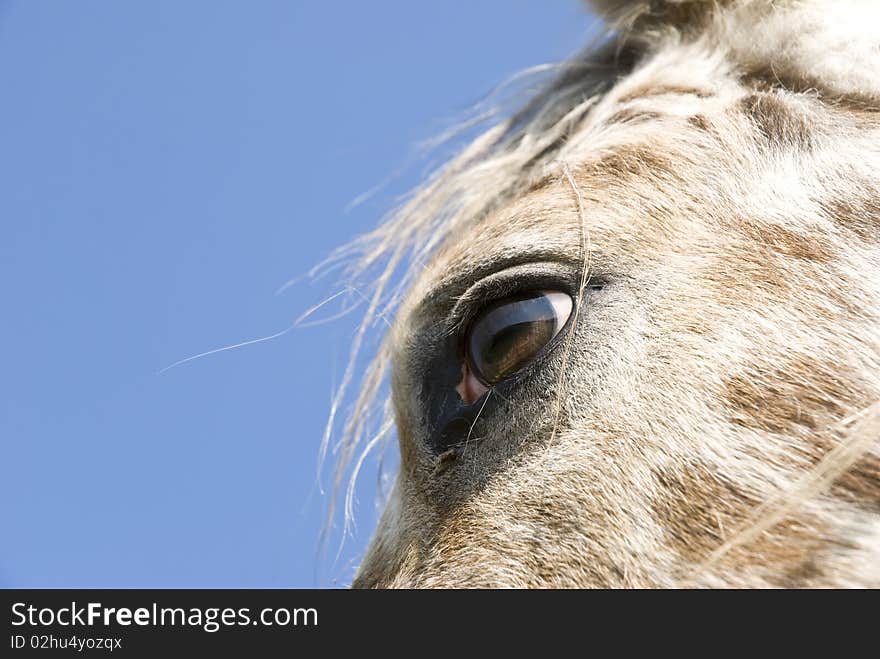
[{"x1": 0, "y1": 0, "x2": 590, "y2": 587}]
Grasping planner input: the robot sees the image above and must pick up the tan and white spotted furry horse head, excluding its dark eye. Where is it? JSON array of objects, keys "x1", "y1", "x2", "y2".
[{"x1": 340, "y1": 0, "x2": 880, "y2": 587}]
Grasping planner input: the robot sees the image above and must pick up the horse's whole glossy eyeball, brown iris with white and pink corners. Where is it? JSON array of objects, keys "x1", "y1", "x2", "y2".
[{"x1": 462, "y1": 291, "x2": 572, "y2": 392}]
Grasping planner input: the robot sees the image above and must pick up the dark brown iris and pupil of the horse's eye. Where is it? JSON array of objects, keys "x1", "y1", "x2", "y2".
[{"x1": 467, "y1": 293, "x2": 557, "y2": 385}]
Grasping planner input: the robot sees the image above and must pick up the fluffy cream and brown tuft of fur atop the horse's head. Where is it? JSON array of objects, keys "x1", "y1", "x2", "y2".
[{"x1": 586, "y1": 0, "x2": 880, "y2": 106}]
